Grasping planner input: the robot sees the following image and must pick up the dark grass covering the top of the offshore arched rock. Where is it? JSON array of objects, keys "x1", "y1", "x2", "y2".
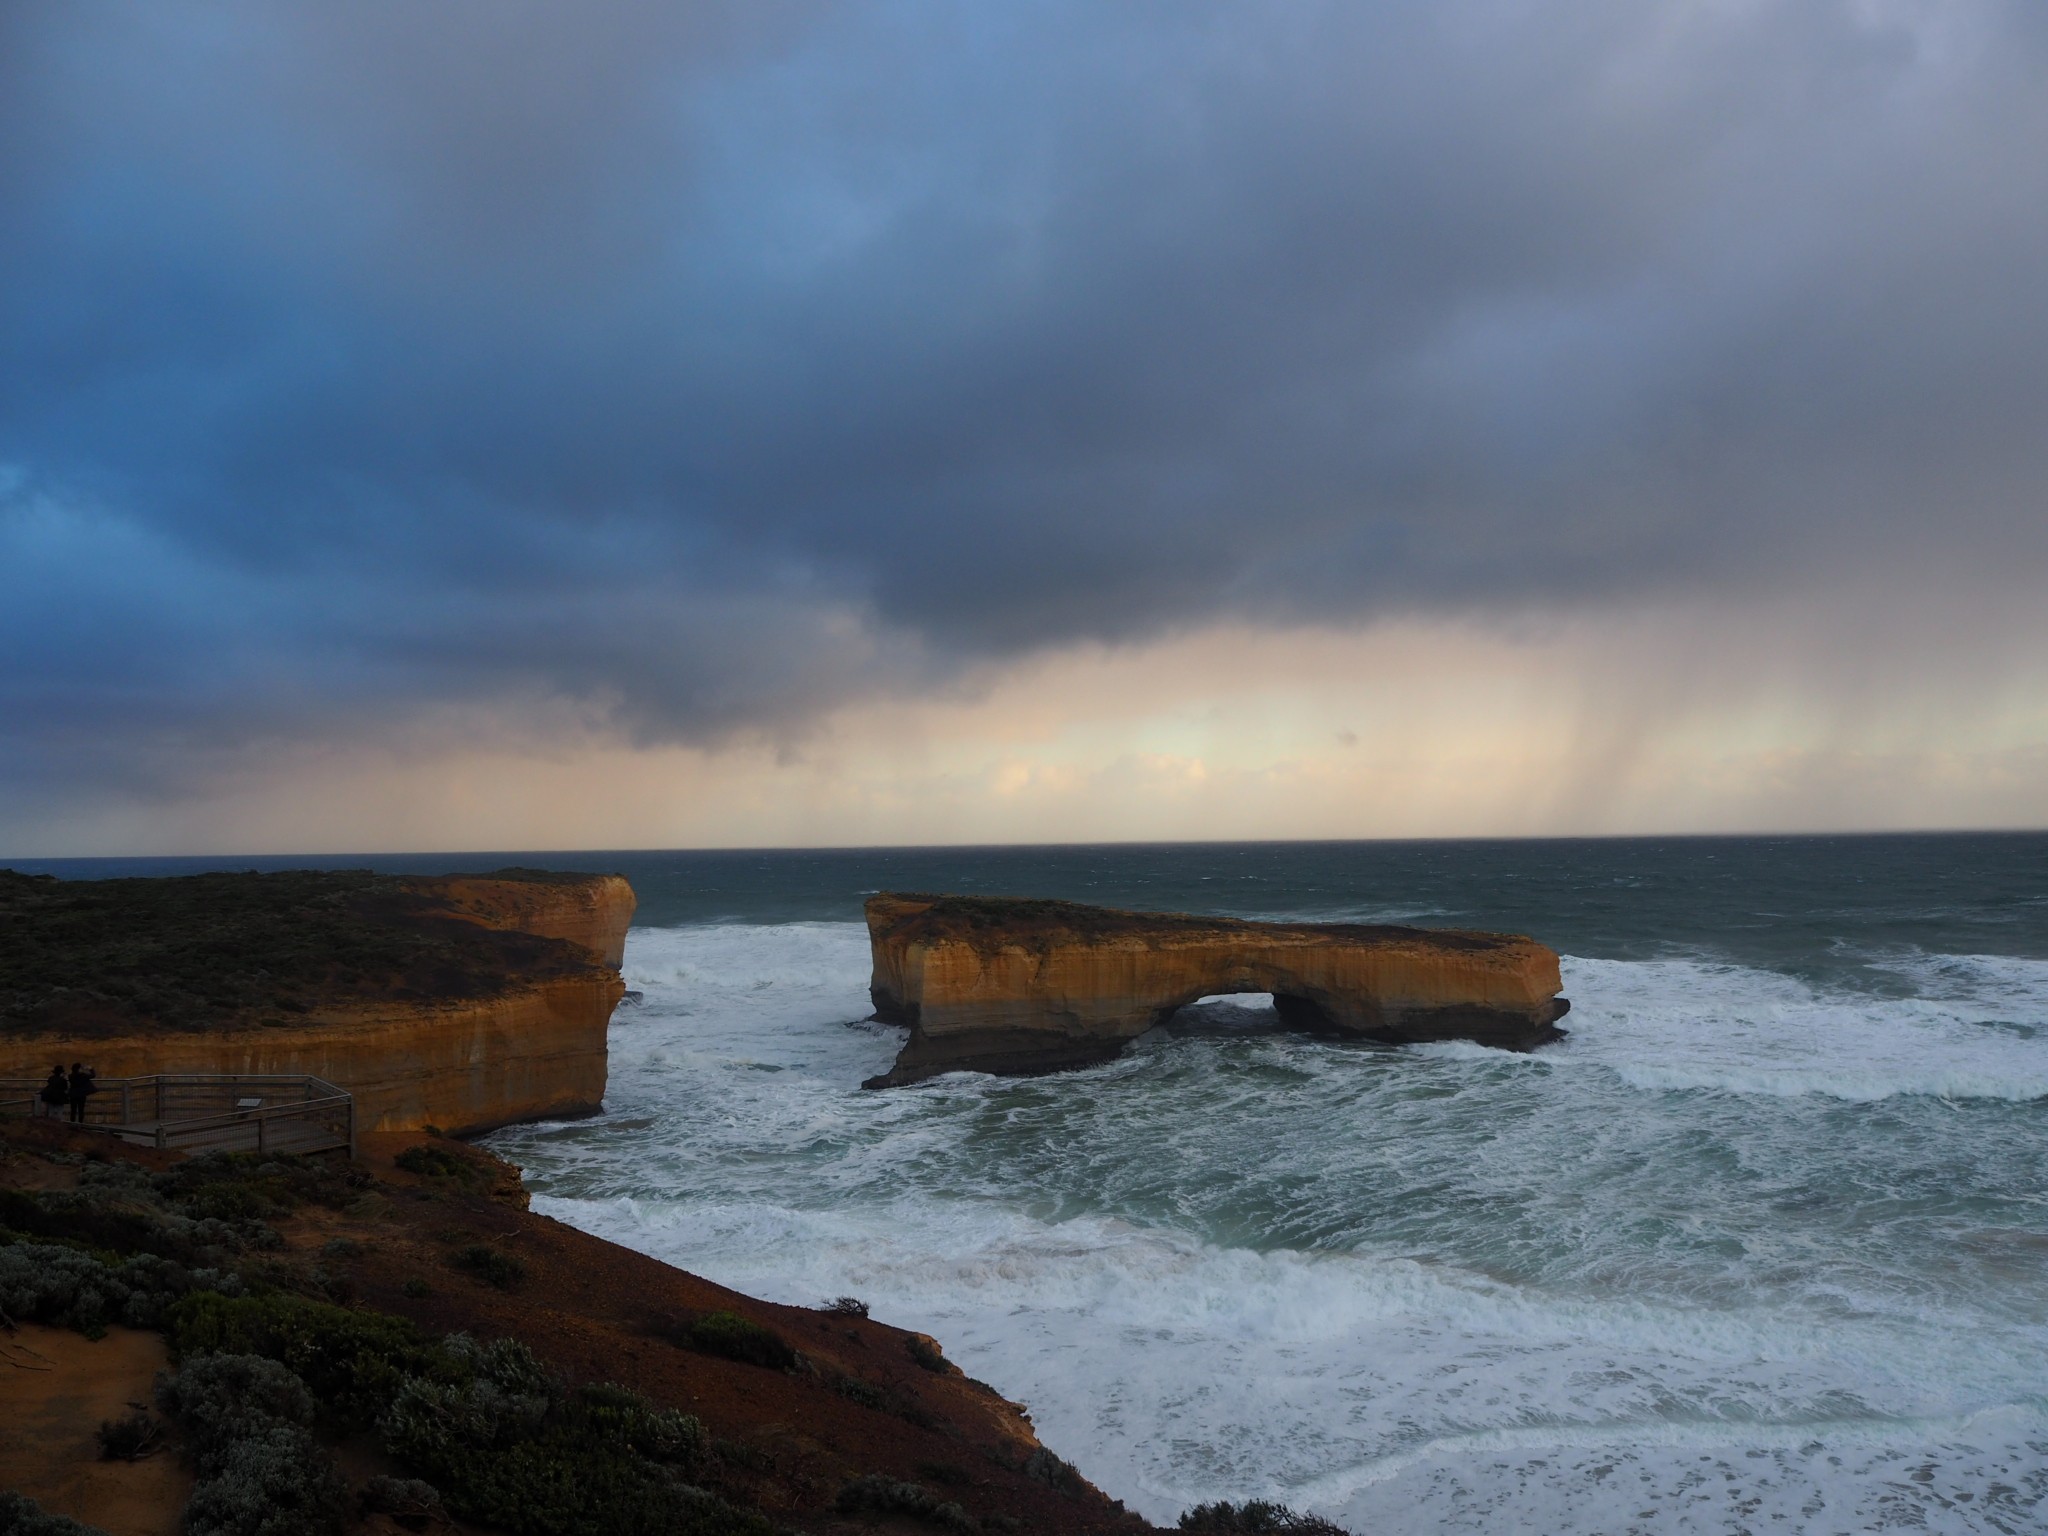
[{"x1": 881, "y1": 891, "x2": 1524, "y2": 950}]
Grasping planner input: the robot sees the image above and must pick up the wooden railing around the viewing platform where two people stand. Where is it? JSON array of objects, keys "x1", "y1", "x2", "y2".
[{"x1": 0, "y1": 1073, "x2": 356, "y2": 1157}]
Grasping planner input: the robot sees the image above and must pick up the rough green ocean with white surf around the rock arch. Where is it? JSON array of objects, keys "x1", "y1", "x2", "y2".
[{"x1": 19, "y1": 834, "x2": 2048, "y2": 1536}]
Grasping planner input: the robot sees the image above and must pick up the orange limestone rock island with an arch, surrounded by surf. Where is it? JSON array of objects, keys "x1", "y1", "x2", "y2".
[{"x1": 866, "y1": 893, "x2": 1571, "y2": 1087}]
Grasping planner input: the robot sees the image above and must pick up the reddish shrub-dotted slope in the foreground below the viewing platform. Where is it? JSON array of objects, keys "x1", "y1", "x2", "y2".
[{"x1": 0, "y1": 1120, "x2": 1153, "y2": 1536}]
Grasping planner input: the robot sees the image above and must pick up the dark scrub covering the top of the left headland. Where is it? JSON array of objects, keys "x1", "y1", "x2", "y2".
[{"x1": 0, "y1": 870, "x2": 594, "y2": 1038}]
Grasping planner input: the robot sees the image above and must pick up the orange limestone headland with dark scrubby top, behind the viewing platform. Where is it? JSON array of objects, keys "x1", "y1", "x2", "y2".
[{"x1": 0, "y1": 870, "x2": 635, "y2": 1133}]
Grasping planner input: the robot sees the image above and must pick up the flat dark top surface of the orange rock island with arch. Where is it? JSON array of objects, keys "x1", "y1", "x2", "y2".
[{"x1": 868, "y1": 891, "x2": 1534, "y2": 952}]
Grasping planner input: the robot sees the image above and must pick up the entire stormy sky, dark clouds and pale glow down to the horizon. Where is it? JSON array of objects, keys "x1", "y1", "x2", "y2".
[{"x1": 0, "y1": 0, "x2": 2048, "y2": 854}]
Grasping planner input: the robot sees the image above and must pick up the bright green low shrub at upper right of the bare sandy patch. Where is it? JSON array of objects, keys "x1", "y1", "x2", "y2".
[{"x1": 166, "y1": 1292, "x2": 451, "y2": 1425}]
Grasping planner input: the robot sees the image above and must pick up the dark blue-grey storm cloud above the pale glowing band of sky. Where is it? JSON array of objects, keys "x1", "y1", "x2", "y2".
[{"x1": 0, "y1": 0, "x2": 2048, "y2": 782}]
